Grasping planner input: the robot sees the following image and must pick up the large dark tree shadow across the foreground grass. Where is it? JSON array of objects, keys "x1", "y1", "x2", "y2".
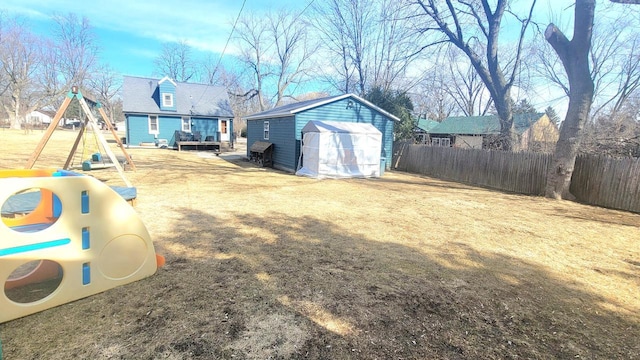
[{"x1": 0, "y1": 208, "x2": 640, "y2": 359}]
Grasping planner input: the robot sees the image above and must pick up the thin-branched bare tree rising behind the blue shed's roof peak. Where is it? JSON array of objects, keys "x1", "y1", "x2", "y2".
[{"x1": 312, "y1": 0, "x2": 416, "y2": 95}]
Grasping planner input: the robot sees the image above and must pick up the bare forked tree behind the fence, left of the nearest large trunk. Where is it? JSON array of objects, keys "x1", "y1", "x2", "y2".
[{"x1": 409, "y1": 0, "x2": 536, "y2": 150}]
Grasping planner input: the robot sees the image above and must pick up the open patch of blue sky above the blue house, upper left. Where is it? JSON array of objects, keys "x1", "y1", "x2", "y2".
[{"x1": 0, "y1": 0, "x2": 308, "y2": 76}]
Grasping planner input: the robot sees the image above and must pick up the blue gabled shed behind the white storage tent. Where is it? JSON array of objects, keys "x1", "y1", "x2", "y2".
[{"x1": 244, "y1": 94, "x2": 400, "y2": 172}]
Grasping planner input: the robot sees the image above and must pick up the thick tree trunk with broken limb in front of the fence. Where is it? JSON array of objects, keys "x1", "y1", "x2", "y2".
[{"x1": 545, "y1": 0, "x2": 595, "y2": 200}]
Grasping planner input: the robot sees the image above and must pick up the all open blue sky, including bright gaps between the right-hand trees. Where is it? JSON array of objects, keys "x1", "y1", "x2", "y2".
[{"x1": 0, "y1": 0, "x2": 624, "y2": 112}]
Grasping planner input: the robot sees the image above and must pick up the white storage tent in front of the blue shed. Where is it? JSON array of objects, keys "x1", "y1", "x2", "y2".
[{"x1": 296, "y1": 121, "x2": 382, "y2": 178}]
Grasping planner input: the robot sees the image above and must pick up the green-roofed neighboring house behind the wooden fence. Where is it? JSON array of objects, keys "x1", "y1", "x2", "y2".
[{"x1": 430, "y1": 113, "x2": 559, "y2": 152}]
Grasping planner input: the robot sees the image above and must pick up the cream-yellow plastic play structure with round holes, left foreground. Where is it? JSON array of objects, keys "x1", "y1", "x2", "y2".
[{"x1": 0, "y1": 170, "x2": 164, "y2": 323}]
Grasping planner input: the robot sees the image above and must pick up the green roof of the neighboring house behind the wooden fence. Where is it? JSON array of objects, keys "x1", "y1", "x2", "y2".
[{"x1": 431, "y1": 113, "x2": 544, "y2": 135}]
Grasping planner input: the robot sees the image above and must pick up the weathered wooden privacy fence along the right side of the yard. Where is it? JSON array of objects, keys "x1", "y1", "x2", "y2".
[{"x1": 393, "y1": 143, "x2": 640, "y2": 213}]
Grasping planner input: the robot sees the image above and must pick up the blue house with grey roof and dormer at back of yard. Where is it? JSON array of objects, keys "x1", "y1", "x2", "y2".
[{"x1": 122, "y1": 76, "x2": 233, "y2": 147}]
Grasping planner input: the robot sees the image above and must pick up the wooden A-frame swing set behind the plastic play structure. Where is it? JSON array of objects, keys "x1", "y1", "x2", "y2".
[{"x1": 25, "y1": 86, "x2": 136, "y2": 188}]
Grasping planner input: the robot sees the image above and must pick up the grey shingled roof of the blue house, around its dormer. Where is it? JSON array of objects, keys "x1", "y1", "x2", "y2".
[{"x1": 122, "y1": 76, "x2": 233, "y2": 117}]
